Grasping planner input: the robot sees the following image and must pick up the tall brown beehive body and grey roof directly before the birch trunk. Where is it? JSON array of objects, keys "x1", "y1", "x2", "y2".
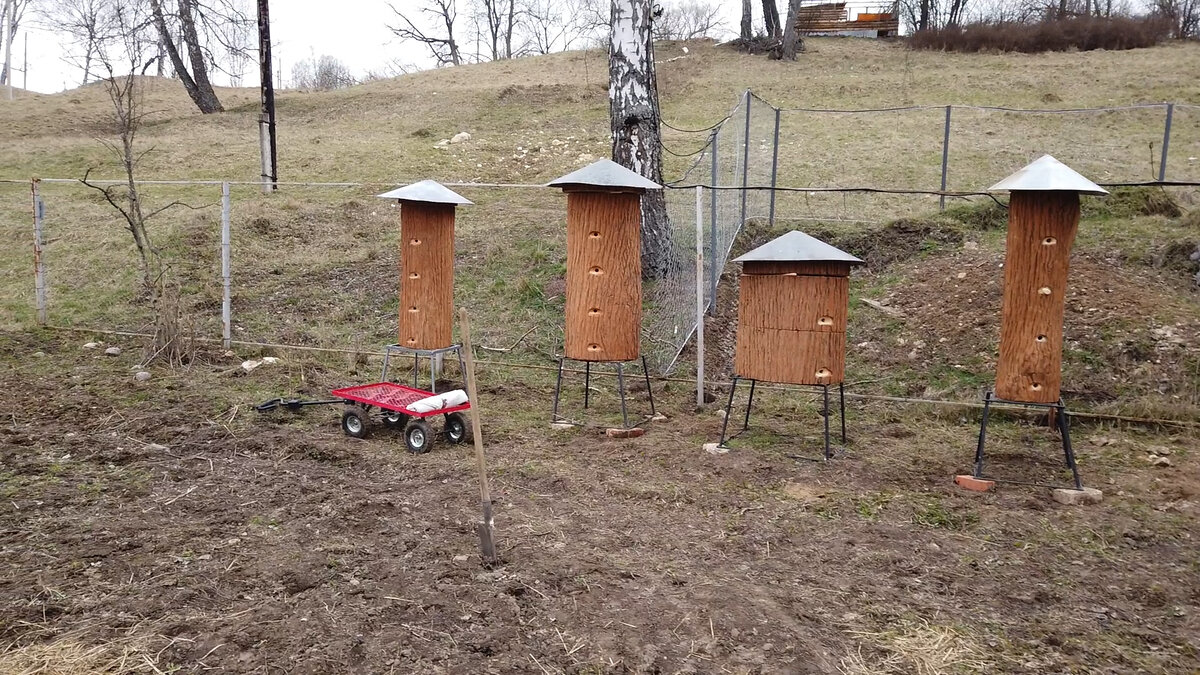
[{"x1": 550, "y1": 160, "x2": 662, "y2": 362}]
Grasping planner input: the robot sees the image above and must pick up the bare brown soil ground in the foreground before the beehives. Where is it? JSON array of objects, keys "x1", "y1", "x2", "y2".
[{"x1": 0, "y1": 324, "x2": 1200, "y2": 673}]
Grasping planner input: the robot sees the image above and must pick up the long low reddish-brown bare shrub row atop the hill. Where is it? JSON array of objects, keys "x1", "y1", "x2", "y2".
[{"x1": 908, "y1": 17, "x2": 1171, "y2": 54}]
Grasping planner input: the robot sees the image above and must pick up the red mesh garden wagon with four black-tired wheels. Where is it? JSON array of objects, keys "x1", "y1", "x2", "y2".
[{"x1": 330, "y1": 382, "x2": 470, "y2": 453}]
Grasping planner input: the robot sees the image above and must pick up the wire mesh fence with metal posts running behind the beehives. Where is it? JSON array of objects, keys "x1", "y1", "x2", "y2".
[{"x1": 0, "y1": 91, "x2": 1200, "y2": 375}]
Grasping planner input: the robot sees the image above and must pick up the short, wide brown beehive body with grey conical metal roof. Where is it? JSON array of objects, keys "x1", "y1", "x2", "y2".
[{"x1": 733, "y1": 231, "x2": 863, "y2": 384}]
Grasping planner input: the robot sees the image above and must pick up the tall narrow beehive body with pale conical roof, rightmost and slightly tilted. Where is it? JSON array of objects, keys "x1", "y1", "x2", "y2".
[{"x1": 990, "y1": 155, "x2": 1108, "y2": 404}]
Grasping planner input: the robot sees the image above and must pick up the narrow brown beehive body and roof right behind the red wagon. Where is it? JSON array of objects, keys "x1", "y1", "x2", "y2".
[{"x1": 379, "y1": 180, "x2": 470, "y2": 350}]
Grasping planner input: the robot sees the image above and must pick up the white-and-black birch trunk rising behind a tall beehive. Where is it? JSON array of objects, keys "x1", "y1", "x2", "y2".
[{"x1": 608, "y1": 0, "x2": 672, "y2": 279}]
